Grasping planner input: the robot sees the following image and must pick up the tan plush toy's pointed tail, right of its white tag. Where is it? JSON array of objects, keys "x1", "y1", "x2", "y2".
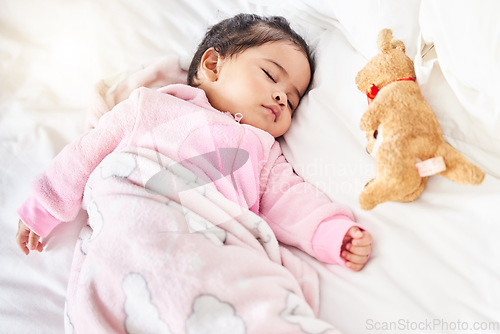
[{"x1": 436, "y1": 143, "x2": 485, "y2": 185}]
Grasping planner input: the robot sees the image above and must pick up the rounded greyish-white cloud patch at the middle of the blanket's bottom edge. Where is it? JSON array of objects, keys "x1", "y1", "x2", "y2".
[{"x1": 186, "y1": 295, "x2": 245, "y2": 334}]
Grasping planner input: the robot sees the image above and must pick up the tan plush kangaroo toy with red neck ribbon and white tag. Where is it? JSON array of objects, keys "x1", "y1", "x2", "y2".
[{"x1": 356, "y1": 29, "x2": 485, "y2": 210}]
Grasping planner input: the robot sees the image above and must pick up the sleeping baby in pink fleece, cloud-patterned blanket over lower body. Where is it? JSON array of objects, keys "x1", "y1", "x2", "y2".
[{"x1": 17, "y1": 14, "x2": 372, "y2": 333}]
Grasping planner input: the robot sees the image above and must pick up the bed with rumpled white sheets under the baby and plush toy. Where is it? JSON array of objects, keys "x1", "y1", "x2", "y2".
[{"x1": 0, "y1": 0, "x2": 500, "y2": 334}]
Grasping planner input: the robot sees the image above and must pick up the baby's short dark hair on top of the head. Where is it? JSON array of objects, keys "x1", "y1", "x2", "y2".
[{"x1": 188, "y1": 14, "x2": 314, "y2": 86}]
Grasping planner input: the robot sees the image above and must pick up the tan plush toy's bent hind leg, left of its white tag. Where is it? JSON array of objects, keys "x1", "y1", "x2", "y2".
[{"x1": 359, "y1": 145, "x2": 426, "y2": 210}]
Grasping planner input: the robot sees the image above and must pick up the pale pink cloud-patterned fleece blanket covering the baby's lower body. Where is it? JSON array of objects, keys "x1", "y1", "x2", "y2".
[{"x1": 66, "y1": 148, "x2": 338, "y2": 334}]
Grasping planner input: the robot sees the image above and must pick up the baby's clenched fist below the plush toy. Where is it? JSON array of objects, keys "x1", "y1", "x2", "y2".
[{"x1": 341, "y1": 226, "x2": 372, "y2": 271}]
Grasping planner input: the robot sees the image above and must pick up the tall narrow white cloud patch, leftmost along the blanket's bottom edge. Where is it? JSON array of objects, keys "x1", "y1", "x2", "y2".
[{"x1": 122, "y1": 273, "x2": 172, "y2": 334}]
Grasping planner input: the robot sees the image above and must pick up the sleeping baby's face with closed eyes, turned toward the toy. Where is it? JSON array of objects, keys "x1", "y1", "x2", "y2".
[{"x1": 205, "y1": 41, "x2": 311, "y2": 138}]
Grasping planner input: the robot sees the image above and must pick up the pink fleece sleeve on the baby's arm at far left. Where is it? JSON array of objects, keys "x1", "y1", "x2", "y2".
[{"x1": 18, "y1": 90, "x2": 139, "y2": 237}]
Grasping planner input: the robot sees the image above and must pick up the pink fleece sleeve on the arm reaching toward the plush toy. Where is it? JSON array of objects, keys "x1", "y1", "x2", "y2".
[{"x1": 260, "y1": 145, "x2": 355, "y2": 264}]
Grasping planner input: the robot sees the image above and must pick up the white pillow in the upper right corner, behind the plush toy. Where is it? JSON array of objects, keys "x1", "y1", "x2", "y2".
[{"x1": 416, "y1": 0, "x2": 500, "y2": 177}]
